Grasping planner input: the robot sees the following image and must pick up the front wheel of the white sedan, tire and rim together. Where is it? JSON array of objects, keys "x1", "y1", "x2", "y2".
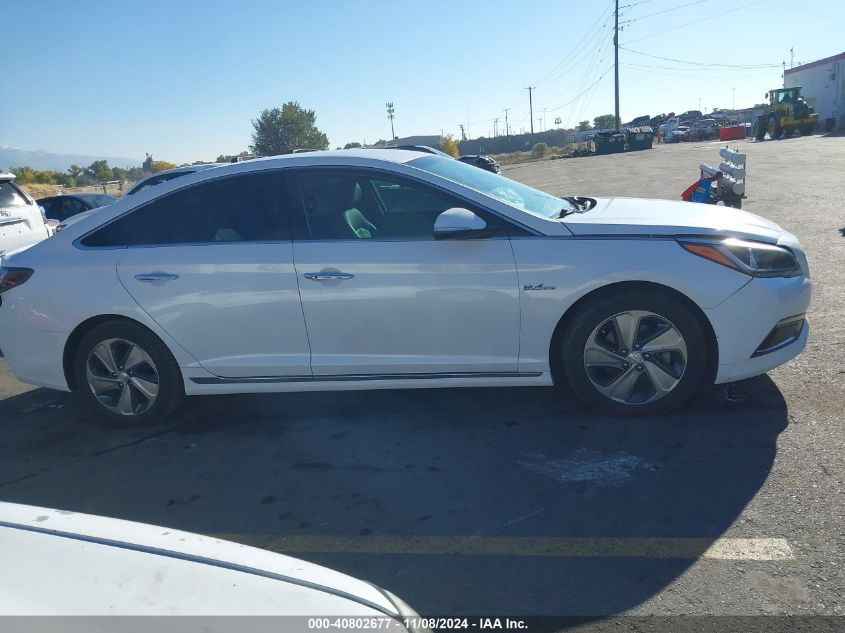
[{"x1": 561, "y1": 289, "x2": 707, "y2": 414}]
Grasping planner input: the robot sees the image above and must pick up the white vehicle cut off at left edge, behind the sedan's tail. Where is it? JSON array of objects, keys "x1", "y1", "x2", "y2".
[{"x1": 0, "y1": 173, "x2": 53, "y2": 259}]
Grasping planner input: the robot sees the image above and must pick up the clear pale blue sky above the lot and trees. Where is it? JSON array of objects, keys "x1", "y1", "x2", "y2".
[{"x1": 0, "y1": 0, "x2": 845, "y2": 163}]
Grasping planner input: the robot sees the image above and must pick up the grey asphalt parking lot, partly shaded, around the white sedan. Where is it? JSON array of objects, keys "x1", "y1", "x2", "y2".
[{"x1": 0, "y1": 136, "x2": 845, "y2": 616}]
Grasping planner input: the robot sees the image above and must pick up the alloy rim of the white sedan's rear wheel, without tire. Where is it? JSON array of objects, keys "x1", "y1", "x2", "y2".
[{"x1": 85, "y1": 338, "x2": 159, "y2": 416}]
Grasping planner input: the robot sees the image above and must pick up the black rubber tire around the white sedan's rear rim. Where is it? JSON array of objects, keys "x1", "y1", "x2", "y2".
[{"x1": 73, "y1": 321, "x2": 185, "y2": 426}]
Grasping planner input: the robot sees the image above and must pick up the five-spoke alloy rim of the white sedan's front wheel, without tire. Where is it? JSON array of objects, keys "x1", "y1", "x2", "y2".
[{"x1": 584, "y1": 310, "x2": 687, "y2": 405}]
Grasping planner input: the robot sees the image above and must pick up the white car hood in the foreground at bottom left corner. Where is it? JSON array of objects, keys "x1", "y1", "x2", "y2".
[{"x1": 0, "y1": 503, "x2": 397, "y2": 617}]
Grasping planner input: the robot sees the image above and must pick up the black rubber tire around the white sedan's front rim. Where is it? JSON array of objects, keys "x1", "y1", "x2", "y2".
[{"x1": 560, "y1": 287, "x2": 708, "y2": 415}]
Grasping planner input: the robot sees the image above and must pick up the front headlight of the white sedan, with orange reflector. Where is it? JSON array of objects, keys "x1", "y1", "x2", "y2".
[{"x1": 678, "y1": 237, "x2": 801, "y2": 277}]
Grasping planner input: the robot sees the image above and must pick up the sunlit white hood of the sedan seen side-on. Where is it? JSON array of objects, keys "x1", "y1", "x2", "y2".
[{"x1": 562, "y1": 198, "x2": 784, "y2": 243}]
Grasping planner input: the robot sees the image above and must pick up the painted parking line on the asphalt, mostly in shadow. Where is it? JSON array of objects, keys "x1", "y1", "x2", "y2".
[{"x1": 215, "y1": 534, "x2": 795, "y2": 561}]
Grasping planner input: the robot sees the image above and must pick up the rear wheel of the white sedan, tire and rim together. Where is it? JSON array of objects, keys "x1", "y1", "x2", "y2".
[{"x1": 74, "y1": 321, "x2": 185, "y2": 425}]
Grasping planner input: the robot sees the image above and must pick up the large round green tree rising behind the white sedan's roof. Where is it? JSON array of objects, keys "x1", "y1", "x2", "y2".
[{"x1": 250, "y1": 101, "x2": 329, "y2": 156}]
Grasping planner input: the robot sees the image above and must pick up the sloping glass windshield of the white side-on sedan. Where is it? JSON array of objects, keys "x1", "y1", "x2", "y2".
[{"x1": 408, "y1": 156, "x2": 575, "y2": 219}]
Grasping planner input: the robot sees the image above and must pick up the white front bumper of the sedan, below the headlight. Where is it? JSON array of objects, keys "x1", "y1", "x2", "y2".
[{"x1": 706, "y1": 275, "x2": 812, "y2": 384}]
